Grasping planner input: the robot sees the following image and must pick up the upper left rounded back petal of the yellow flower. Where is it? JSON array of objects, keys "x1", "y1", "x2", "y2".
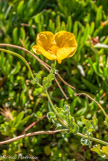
[{"x1": 36, "y1": 31, "x2": 54, "y2": 50}]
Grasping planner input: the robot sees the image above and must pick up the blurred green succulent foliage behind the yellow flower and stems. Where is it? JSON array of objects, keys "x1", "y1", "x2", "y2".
[{"x1": 0, "y1": 0, "x2": 108, "y2": 161}]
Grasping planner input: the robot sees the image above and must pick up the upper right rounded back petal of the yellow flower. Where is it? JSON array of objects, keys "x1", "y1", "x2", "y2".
[{"x1": 55, "y1": 31, "x2": 77, "y2": 48}]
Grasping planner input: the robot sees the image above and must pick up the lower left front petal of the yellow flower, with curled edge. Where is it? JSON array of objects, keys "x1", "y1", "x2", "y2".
[{"x1": 32, "y1": 45, "x2": 57, "y2": 60}]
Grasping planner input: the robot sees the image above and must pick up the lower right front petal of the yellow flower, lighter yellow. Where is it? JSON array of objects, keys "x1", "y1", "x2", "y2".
[{"x1": 57, "y1": 47, "x2": 76, "y2": 64}]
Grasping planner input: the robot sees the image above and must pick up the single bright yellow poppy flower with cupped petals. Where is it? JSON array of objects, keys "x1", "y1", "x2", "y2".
[{"x1": 32, "y1": 31, "x2": 77, "y2": 63}]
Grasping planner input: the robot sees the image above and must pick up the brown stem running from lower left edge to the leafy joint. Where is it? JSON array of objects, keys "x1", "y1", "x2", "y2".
[{"x1": 0, "y1": 129, "x2": 68, "y2": 145}]
